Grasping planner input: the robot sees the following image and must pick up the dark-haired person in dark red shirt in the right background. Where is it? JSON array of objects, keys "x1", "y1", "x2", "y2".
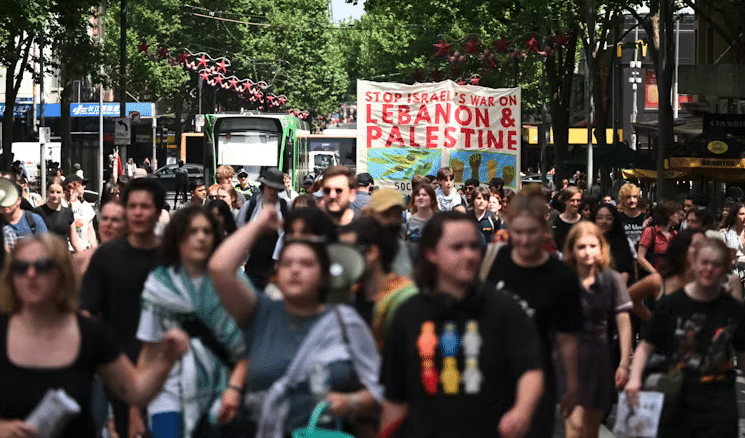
[{"x1": 636, "y1": 201, "x2": 678, "y2": 277}]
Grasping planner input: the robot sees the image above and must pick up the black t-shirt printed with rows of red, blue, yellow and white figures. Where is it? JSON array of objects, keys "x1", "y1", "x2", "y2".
[{"x1": 381, "y1": 287, "x2": 542, "y2": 438}]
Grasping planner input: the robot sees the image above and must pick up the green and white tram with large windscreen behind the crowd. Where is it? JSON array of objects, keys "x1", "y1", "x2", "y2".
[{"x1": 204, "y1": 113, "x2": 310, "y2": 190}]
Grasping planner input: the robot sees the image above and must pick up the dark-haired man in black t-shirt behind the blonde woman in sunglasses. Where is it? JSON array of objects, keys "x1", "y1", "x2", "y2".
[{"x1": 80, "y1": 178, "x2": 165, "y2": 437}]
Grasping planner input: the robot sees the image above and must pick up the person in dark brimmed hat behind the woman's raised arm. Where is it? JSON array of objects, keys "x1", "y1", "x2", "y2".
[{"x1": 238, "y1": 167, "x2": 289, "y2": 290}]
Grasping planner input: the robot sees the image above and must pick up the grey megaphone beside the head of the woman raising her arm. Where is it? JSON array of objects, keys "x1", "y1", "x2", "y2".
[{"x1": 326, "y1": 243, "x2": 365, "y2": 303}]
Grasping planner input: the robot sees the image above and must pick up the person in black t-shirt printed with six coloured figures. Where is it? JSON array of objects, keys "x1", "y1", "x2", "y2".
[{"x1": 380, "y1": 212, "x2": 544, "y2": 438}]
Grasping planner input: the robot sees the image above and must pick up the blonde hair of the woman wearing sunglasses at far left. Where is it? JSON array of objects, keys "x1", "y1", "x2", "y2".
[{"x1": 0, "y1": 233, "x2": 78, "y2": 314}]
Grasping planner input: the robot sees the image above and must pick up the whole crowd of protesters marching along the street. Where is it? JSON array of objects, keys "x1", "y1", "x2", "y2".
[{"x1": 0, "y1": 163, "x2": 745, "y2": 438}]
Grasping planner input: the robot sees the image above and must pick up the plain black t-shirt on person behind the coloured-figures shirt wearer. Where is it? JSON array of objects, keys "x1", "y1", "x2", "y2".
[{"x1": 487, "y1": 246, "x2": 584, "y2": 375}]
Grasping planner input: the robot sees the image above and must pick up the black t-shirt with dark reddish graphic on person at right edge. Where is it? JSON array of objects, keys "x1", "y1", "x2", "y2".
[{"x1": 642, "y1": 289, "x2": 745, "y2": 383}]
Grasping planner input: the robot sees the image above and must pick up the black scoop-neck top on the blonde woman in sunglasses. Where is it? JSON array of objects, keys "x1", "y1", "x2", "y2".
[{"x1": 0, "y1": 315, "x2": 120, "y2": 438}]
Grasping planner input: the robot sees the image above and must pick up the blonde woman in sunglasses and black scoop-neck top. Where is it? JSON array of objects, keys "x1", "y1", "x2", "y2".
[{"x1": 0, "y1": 234, "x2": 187, "y2": 438}]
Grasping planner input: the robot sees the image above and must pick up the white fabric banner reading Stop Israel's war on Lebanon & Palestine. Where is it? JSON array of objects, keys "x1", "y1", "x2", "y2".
[{"x1": 357, "y1": 80, "x2": 521, "y2": 191}]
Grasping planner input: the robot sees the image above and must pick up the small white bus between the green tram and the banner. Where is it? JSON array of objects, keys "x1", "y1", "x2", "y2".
[{"x1": 296, "y1": 129, "x2": 357, "y2": 175}]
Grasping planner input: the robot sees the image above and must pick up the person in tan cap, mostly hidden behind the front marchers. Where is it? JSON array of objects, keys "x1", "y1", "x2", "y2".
[{"x1": 362, "y1": 189, "x2": 414, "y2": 278}]
